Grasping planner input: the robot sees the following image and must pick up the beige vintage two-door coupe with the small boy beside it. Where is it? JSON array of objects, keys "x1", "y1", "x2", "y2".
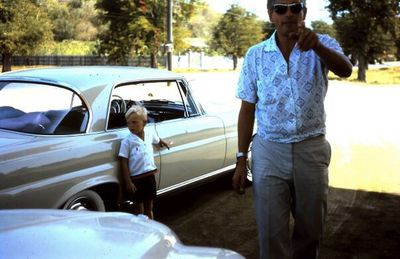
[{"x1": 0, "y1": 66, "x2": 237, "y2": 211}]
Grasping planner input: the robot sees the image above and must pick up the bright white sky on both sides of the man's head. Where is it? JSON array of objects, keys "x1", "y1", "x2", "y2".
[{"x1": 205, "y1": 0, "x2": 332, "y2": 25}]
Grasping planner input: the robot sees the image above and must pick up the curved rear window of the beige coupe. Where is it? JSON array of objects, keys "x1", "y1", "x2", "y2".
[{"x1": 0, "y1": 82, "x2": 89, "y2": 135}]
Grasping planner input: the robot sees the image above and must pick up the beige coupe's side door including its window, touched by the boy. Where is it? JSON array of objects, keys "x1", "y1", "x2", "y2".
[{"x1": 110, "y1": 80, "x2": 226, "y2": 192}]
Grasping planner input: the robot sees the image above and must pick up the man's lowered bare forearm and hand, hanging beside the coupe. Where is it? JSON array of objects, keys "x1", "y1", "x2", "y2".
[{"x1": 232, "y1": 101, "x2": 255, "y2": 193}]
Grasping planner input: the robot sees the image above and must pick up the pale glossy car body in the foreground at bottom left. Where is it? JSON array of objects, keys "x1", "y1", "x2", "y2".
[{"x1": 0, "y1": 210, "x2": 243, "y2": 259}]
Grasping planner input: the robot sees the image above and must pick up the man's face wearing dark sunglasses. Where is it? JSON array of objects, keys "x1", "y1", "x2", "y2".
[{"x1": 268, "y1": 0, "x2": 307, "y2": 37}]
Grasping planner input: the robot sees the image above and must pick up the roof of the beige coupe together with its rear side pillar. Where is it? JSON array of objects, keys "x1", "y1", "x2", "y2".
[{"x1": 0, "y1": 66, "x2": 189, "y2": 132}]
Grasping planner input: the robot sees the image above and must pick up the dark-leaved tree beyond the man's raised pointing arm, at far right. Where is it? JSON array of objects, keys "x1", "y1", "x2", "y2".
[{"x1": 328, "y1": 0, "x2": 400, "y2": 81}]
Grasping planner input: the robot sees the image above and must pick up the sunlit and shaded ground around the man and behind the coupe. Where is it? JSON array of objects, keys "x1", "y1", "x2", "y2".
[{"x1": 155, "y1": 73, "x2": 400, "y2": 259}]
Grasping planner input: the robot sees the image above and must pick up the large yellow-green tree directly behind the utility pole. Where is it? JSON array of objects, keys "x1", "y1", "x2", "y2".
[{"x1": 96, "y1": 0, "x2": 198, "y2": 67}]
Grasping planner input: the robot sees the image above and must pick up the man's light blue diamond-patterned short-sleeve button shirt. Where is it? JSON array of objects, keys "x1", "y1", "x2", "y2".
[{"x1": 236, "y1": 33, "x2": 343, "y2": 143}]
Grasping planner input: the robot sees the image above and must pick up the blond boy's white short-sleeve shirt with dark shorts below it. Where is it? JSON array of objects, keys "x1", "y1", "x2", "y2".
[{"x1": 118, "y1": 131, "x2": 160, "y2": 176}]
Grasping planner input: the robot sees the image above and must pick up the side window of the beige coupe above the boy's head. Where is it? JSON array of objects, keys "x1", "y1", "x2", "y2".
[{"x1": 108, "y1": 81, "x2": 199, "y2": 129}]
